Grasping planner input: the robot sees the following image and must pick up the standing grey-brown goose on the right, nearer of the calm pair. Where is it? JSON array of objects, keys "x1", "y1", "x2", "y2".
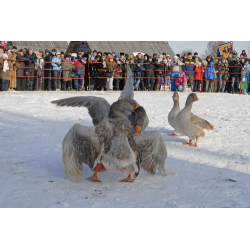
[{"x1": 175, "y1": 93, "x2": 214, "y2": 147}]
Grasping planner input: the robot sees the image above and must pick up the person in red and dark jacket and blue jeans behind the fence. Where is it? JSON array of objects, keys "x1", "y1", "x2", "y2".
[{"x1": 73, "y1": 52, "x2": 87, "y2": 91}]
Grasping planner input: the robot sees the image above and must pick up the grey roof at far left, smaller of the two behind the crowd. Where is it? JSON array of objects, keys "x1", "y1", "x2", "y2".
[{"x1": 7, "y1": 41, "x2": 68, "y2": 52}]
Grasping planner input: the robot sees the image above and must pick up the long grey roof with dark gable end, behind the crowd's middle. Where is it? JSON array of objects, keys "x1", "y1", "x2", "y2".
[{"x1": 69, "y1": 41, "x2": 175, "y2": 57}]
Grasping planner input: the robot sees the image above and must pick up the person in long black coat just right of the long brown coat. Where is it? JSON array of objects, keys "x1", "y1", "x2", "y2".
[{"x1": 25, "y1": 48, "x2": 37, "y2": 91}]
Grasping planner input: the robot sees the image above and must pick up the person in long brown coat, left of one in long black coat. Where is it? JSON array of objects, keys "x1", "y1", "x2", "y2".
[{"x1": 16, "y1": 49, "x2": 28, "y2": 91}]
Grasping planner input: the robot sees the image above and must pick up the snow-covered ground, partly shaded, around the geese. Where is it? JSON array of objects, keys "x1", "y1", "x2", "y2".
[{"x1": 0, "y1": 92, "x2": 250, "y2": 208}]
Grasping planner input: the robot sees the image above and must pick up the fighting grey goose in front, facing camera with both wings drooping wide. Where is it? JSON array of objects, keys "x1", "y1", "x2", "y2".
[{"x1": 63, "y1": 100, "x2": 167, "y2": 182}]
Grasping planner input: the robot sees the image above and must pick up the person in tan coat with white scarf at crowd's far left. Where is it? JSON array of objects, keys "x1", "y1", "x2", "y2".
[{"x1": 0, "y1": 54, "x2": 12, "y2": 91}]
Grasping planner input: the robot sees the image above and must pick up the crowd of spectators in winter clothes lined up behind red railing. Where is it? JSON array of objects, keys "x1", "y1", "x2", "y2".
[{"x1": 0, "y1": 44, "x2": 250, "y2": 94}]
